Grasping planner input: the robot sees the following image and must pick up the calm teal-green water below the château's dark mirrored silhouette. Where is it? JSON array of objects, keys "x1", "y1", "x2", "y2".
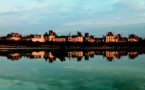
[{"x1": 0, "y1": 51, "x2": 145, "y2": 90}]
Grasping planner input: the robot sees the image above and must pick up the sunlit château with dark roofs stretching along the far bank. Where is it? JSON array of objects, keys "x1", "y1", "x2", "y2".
[{"x1": 0, "y1": 30, "x2": 145, "y2": 43}]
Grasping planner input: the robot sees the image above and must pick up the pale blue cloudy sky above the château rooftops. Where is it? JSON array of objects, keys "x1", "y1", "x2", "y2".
[{"x1": 0, "y1": 0, "x2": 145, "y2": 37}]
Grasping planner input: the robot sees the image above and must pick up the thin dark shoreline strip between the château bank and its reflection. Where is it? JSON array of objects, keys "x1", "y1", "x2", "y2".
[{"x1": 0, "y1": 47, "x2": 145, "y2": 51}]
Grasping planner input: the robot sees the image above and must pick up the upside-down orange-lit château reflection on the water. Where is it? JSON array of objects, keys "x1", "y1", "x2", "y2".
[{"x1": 0, "y1": 50, "x2": 145, "y2": 63}]
